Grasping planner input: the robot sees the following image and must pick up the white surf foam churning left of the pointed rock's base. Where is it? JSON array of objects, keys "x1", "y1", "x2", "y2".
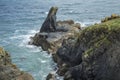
[{"x1": 10, "y1": 30, "x2": 39, "y2": 48}]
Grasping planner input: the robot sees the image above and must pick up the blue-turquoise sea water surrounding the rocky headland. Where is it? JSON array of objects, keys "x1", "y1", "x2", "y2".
[{"x1": 0, "y1": 0, "x2": 120, "y2": 80}]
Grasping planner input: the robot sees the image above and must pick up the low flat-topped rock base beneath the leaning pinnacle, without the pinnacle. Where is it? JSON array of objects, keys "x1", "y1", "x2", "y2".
[{"x1": 29, "y1": 20, "x2": 80, "y2": 53}]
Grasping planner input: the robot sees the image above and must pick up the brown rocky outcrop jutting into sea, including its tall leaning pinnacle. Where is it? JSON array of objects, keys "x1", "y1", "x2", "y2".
[{"x1": 29, "y1": 7, "x2": 81, "y2": 54}]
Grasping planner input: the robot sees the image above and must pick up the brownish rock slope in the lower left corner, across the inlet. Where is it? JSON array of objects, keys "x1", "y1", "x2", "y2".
[{"x1": 0, "y1": 47, "x2": 34, "y2": 80}]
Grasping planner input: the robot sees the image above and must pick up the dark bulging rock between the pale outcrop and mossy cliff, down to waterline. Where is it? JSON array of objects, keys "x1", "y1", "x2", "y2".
[{"x1": 56, "y1": 38, "x2": 83, "y2": 76}]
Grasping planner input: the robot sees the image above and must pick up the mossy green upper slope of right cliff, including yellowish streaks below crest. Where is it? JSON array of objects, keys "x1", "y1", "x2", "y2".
[{"x1": 76, "y1": 15, "x2": 120, "y2": 58}]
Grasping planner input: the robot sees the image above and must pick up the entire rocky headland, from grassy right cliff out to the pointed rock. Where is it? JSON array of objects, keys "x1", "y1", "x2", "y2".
[{"x1": 30, "y1": 6, "x2": 120, "y2": 80}]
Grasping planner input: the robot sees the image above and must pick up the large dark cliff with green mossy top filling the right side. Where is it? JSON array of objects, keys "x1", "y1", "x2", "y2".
[{"x1": 56, "y1": 18, "x2": 120, "y2": 80}]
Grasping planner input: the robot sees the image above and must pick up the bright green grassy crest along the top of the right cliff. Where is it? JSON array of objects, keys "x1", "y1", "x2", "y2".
[{"x1": 78, "y1": 18, "x2": 120, "y2": 43}]
